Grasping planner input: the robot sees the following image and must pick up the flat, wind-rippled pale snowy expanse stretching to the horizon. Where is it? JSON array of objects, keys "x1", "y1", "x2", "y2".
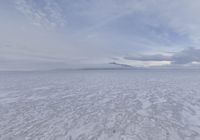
[{"x1": 0, "y1": 70, "x2": 200, "y2": 140}]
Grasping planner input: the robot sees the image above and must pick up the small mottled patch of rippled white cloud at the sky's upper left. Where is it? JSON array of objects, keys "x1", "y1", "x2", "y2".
[{"x1": 15, "y1": 0, "x2": 67, "y2": 28}]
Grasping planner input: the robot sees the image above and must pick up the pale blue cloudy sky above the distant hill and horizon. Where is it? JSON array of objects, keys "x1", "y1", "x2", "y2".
[{"x1": 0, "y1": 0, "x2": 200, "y2": 70}]
